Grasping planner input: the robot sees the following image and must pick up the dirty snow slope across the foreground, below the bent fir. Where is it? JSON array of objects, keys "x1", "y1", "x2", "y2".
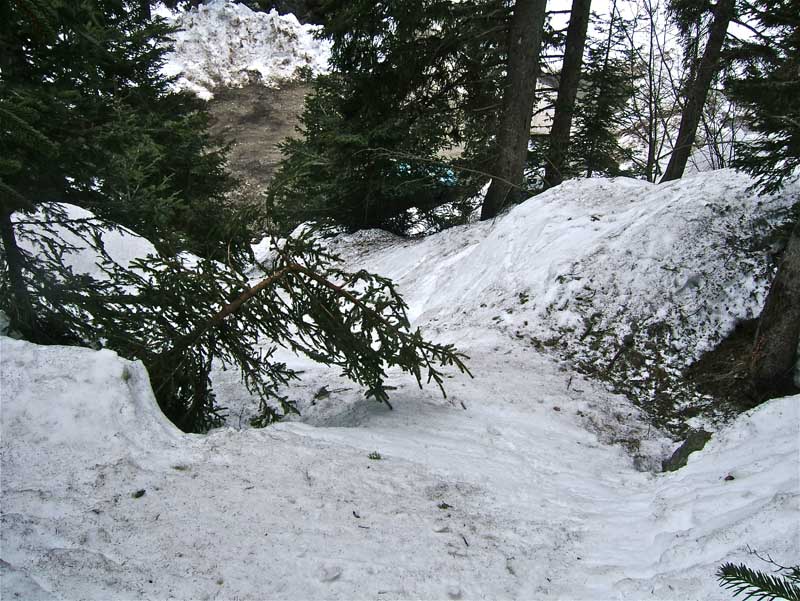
[{"x1": 0, "y1": 333, "x2": 800, "y2": 599}]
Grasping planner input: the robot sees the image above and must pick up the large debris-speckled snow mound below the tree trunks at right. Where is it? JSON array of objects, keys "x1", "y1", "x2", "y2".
[{"x1": 324, "y1": 170, "x2": 796, "y2": 422}]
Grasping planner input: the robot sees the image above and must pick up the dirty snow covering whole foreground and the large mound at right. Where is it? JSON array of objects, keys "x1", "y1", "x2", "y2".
[{"x1": 0, "y1": 172, "x2": 800, "y2": 599}]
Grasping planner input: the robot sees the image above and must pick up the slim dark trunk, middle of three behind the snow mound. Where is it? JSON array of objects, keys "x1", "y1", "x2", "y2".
[{"x1": 544, "y1": 0, "x2": 592, "y2": 188}]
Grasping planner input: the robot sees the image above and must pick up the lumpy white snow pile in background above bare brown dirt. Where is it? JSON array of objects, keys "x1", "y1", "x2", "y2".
[{"x1": 162, "y1": 0, "x2": 330, "y2": 100}]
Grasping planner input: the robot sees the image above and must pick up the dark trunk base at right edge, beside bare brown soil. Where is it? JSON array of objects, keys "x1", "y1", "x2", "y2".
[{"x1": 750, "y1": 222, "x2": 800, "y2": 397}]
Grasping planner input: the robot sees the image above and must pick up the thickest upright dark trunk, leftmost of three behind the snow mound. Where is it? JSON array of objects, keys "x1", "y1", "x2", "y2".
[{"x1": 481, "y1": 0, "x2": 546, "y2": 219}]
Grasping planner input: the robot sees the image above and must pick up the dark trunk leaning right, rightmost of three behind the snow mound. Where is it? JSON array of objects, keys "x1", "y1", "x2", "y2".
[{"x1": 661, "y1": 0, "x2": 735, "y2": 183}]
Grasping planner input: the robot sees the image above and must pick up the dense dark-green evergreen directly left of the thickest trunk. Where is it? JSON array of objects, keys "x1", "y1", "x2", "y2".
[{"x1": 270, "y1": 0, "x2": 508, "y2": 233}]
